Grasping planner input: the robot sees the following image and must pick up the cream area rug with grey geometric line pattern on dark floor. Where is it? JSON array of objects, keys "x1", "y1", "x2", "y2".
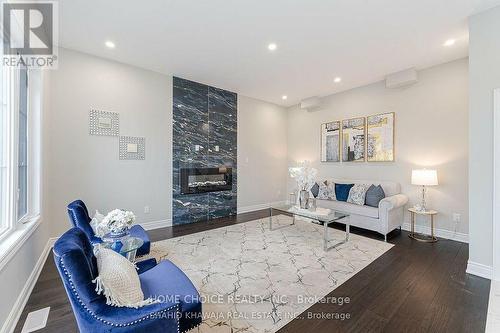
[{"x1": 146, "y1": 215, "x2": 392, "y2": 333}]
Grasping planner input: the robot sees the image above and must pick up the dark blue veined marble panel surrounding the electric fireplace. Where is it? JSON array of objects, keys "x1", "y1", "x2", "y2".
[{"x1": 172, "y1": 77, "x2": 237, "y2": 225}]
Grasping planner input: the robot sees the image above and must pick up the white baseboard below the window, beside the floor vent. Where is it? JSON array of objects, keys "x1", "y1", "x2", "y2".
[{"x1": 0, "y1": 237, "x2": 57, "y2": 333}]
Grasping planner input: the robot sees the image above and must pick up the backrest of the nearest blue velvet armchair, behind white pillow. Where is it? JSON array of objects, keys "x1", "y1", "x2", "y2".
[{"x1": 52, "y1": 228, "x2": 102, "y2": 327}]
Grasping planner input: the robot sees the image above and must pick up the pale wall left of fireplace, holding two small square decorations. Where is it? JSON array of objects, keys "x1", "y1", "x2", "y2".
[{"x1": 46, "y1": 49, "x2": 172, "y2": 236}]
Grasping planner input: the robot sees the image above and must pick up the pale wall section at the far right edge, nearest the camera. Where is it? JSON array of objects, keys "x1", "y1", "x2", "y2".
[{"x1": 469, "y1": 7, "x2": 500, "y2": 267}]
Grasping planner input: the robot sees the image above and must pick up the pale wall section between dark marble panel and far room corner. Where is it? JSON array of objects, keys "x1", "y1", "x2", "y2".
[{"x1": 238, "y1": 95, "x2": 287, "y2": 212}]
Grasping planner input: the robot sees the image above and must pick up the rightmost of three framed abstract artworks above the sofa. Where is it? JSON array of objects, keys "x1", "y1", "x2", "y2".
[{"x1": 366, "y1": 112, "x2": 394, "y2": 162}]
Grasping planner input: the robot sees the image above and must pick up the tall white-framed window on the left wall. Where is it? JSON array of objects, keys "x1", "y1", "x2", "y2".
[{"x1": 0, "y1": 58, "x2": 41, "y2": 239}]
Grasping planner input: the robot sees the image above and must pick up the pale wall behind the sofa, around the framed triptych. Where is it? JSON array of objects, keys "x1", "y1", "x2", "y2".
[{"x1": 288, "y1": 59, "x2": 468, "y2": 234}]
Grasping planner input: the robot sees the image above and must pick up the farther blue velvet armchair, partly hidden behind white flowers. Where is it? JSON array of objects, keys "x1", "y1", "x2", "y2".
[{"x1": 68, "y1": 200, "x2": 151, "y2": 256}]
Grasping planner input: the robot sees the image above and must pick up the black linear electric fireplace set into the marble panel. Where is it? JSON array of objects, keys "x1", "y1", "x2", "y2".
[{"x1": 180, "y1": 167, "x2": 233, "y2": 194}]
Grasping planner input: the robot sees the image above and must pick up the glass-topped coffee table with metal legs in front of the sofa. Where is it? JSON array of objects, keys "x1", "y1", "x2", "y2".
[{"x1": 269, "y1": 205, "x2": 350, "y2": 251}]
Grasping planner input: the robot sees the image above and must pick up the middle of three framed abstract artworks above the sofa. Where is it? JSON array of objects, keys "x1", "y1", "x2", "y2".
[{"x1": 342, "y1": 117, "x2": 366, "y2": 162}]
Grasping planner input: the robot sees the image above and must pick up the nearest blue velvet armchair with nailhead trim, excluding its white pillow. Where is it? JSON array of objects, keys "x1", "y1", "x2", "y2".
[{"x1": 53, "y1": 228, "x2": 202, "y2": 333}]
